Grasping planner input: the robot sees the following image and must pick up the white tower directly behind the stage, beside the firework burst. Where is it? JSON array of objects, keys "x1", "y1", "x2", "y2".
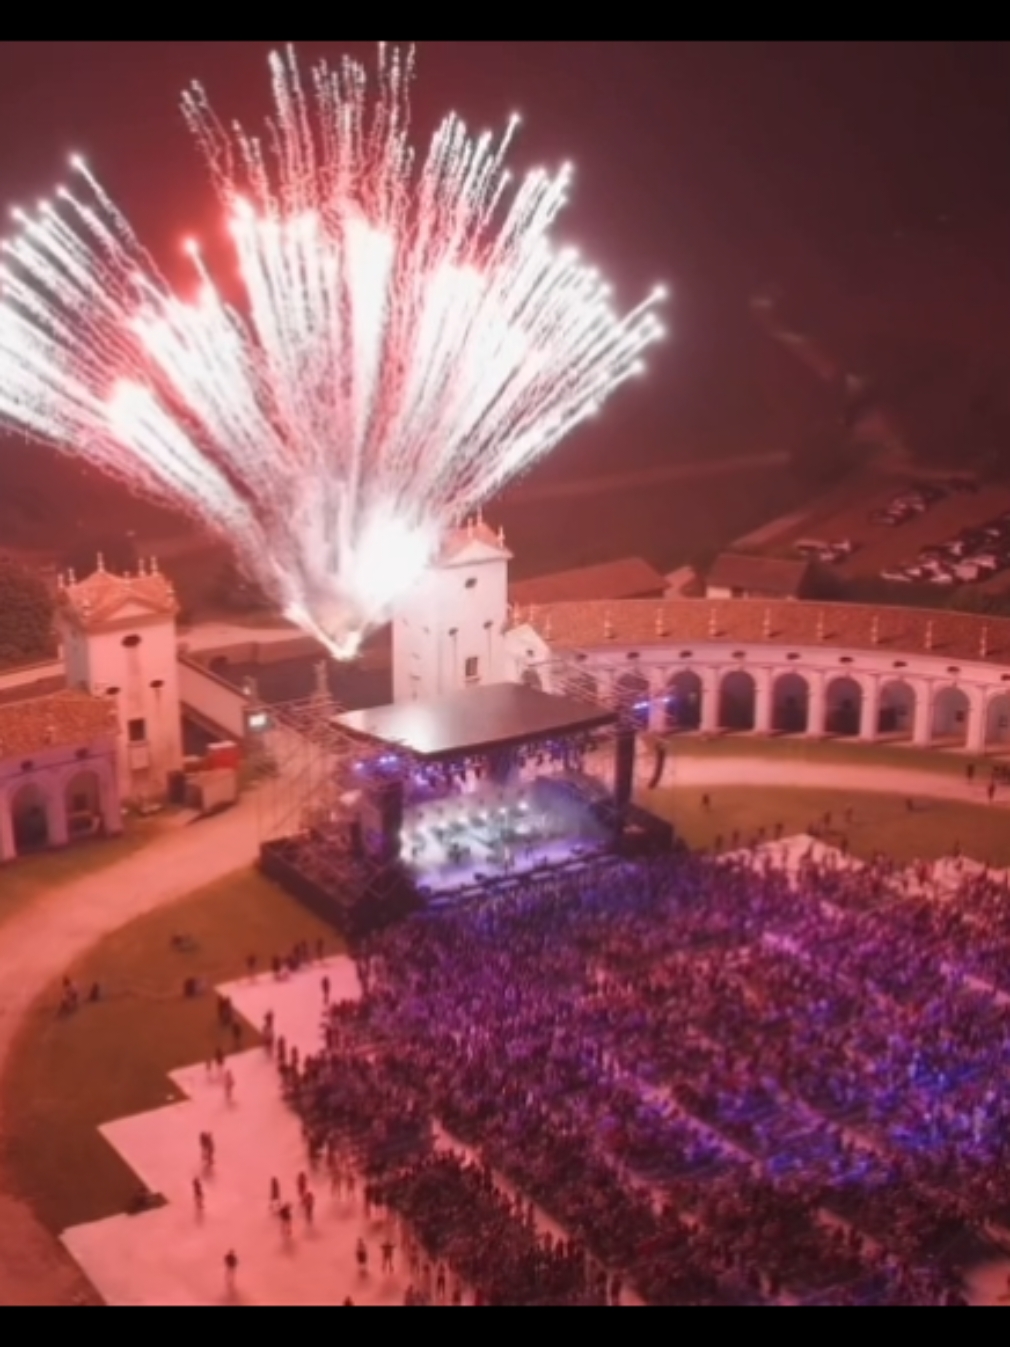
[{"x1": 393, "y1": 520, "x2": 512, "y2": 702}]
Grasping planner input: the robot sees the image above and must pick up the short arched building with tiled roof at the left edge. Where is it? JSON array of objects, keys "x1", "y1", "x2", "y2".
[{"x1": 0, "y1": 691, "x2": 123, "y2": 863}]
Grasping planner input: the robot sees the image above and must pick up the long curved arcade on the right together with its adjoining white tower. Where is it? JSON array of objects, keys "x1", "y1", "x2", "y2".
[{"x1": 393, "y1": 523, "x2": 1010, "y2": 756}]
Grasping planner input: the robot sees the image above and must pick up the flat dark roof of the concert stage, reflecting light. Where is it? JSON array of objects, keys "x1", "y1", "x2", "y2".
[{"x1": 335, "y1": 683, "x2": 617, "y2": 762}]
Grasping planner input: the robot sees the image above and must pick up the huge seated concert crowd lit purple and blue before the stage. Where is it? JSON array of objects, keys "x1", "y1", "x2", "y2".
[{"x1": 288, "y1": 845, "x2": 1010, "y2": 1307}]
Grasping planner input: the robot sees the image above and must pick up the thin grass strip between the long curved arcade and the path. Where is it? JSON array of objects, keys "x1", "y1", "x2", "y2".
[{"x1": 651, "y1": 734, "x2": 985, "y2": 776}]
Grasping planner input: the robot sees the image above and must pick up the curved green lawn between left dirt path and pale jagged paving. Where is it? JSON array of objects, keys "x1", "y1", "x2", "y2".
[{"x1": 3, "y1": 872, "x2": 339, "y2": 1231}]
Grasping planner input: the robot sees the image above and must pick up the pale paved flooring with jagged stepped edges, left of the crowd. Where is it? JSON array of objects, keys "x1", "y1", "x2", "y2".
[{"x1": 63, "y1": 959, "x2": 420, "y2": 1305}]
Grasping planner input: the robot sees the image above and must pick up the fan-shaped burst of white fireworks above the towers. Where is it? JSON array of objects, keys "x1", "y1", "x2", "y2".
[{"x1": 0, "y1": 44, "x2": 663, "y2": 657}]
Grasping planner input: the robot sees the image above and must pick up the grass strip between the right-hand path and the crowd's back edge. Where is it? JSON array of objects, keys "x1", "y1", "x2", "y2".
[{"x1": 642, "y1": 785, "x2": 1010, "y2": 869}]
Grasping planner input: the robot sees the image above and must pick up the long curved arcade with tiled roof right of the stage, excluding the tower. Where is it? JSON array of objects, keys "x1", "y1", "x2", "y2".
[{"x1": 509, "y1": 599, "x2": 1010, "y2": 756}]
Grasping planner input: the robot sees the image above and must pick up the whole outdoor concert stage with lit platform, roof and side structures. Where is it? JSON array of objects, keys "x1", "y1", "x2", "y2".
[{"x1": 261, "y1": 683, "x2": 672, "y2": 935}]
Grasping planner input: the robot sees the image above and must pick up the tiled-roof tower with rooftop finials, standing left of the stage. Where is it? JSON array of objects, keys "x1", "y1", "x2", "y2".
[{"x1": 57, "y1": 558, "x2": 183, "y2": 803}]
